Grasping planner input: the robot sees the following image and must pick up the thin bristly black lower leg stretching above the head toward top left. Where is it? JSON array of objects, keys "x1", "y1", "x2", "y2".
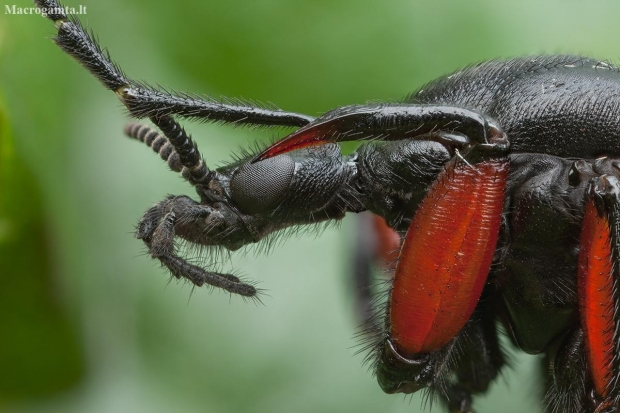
[{"x1": 35, "y1": 0, "x2": 314, "y2": 126}]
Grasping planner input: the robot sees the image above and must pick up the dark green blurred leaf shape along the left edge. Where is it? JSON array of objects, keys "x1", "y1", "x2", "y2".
[{"x1": 0, "y1": 95, "x2": 84, "y2": 403}]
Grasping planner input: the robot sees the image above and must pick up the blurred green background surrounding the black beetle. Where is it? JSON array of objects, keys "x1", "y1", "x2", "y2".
[{"x1": 0, "y1": 0, "x2": 620, "y2": 413}]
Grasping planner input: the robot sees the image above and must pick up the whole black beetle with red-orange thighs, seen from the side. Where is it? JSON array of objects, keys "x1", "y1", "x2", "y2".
[{"x1": 35, "y1": 0, "x2": 620, "y2": 413}]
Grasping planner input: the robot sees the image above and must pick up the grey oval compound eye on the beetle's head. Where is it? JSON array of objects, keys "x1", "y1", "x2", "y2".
[{"x1": 230, "y1": 155, "x2": 295, "y2": 214}]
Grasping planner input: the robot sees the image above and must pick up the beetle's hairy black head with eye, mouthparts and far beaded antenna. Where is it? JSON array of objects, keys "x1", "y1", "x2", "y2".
[{"x1": 128, "y1": 138, "x2": 365, "y2": 297}]
